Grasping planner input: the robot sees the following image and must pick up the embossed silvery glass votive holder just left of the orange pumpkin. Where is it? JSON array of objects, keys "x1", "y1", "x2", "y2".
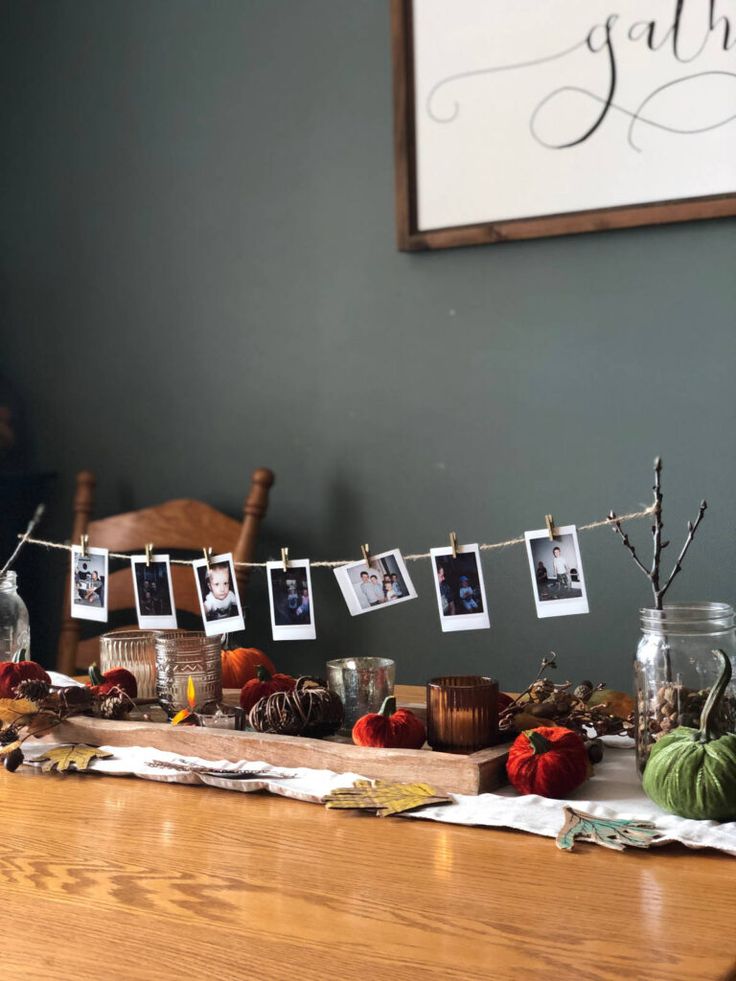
[{"x1": 156, "y1": 630, "x2": 222, "y2": 718}]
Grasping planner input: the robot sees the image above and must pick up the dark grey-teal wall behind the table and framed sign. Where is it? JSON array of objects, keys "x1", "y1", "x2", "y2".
[{"x1": 0, "y1": 0, "x2": 736, "y2": 688}]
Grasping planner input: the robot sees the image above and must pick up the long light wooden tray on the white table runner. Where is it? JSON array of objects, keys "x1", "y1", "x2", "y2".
[{"x1": 45, "y1": 691, "x2": 509, "y2": 794}]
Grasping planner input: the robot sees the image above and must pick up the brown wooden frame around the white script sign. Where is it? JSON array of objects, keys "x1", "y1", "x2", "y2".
[{"x1": 391, "y1": 0, "x2": 736, "y2": 251}]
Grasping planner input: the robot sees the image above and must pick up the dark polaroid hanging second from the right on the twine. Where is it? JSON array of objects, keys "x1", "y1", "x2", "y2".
[{"x1": 429, "y1": 545, "x2": 491, "y2": 633}]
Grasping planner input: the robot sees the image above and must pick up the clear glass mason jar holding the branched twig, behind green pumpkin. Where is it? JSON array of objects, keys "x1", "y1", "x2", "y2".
[{"x1": 634, "y1": 603, "x2": 736, "y2": 772}]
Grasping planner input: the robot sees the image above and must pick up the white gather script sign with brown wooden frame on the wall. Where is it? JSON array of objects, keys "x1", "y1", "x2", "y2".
[{"x1": 391, "y1": 0, "x2": 736, "y2": 250}]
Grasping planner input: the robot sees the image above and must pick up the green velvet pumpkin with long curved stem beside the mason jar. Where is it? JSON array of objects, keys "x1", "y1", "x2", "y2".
[{"x1": 642, "y1": 650, "x2": 736, "y2": 821}]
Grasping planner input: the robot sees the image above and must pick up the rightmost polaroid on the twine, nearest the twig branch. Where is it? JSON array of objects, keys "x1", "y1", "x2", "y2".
[{"x1": 524, "y1": 525, "x2": 589, "y2": 618}]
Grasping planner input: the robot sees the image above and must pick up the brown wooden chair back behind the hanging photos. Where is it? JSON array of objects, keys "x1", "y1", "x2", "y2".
[{"x1": 56, "y1": 467, "x2": 274, "y2": 674}]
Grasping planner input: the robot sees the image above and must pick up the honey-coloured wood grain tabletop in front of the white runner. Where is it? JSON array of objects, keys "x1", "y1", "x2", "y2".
[{"x1": 0, "y1": 684, "x2": 736, "y2": 981}]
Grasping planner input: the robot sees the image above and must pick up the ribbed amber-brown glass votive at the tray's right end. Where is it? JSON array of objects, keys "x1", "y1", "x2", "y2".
[{"x1": 427, "y1": 675, "x2": 498, "y2": 753}]
